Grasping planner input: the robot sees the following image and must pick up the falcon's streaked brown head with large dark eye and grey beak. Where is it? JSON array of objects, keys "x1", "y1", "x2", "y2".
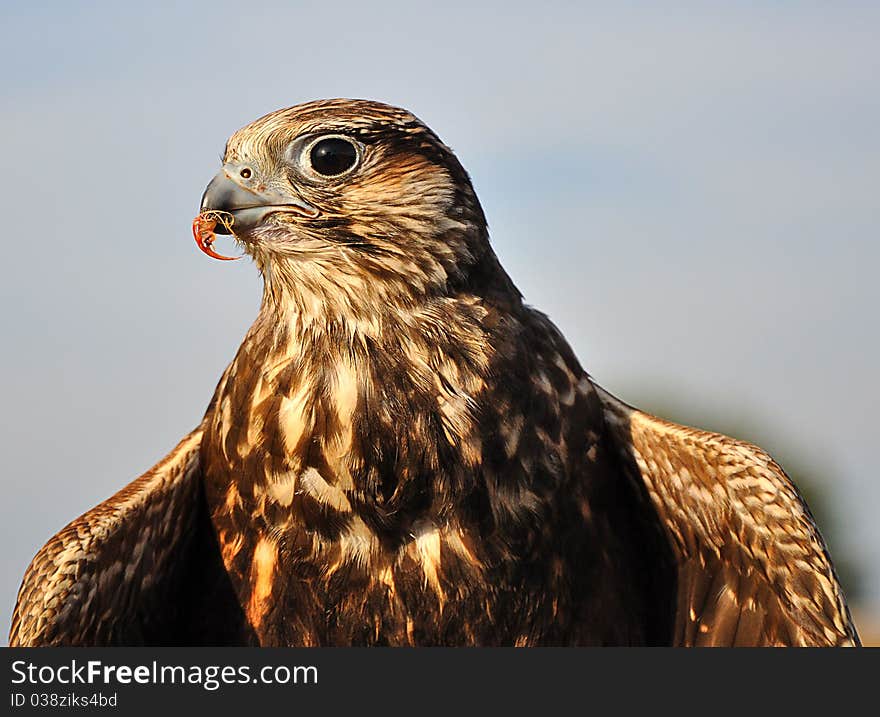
[{"x1": 200, "y1": 99, "x2": 512, "y2": 310}]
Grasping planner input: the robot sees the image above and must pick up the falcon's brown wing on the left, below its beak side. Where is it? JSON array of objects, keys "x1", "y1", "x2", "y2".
[{"x1": 9, "y1": 428, "x2": 202, "y2": 646}]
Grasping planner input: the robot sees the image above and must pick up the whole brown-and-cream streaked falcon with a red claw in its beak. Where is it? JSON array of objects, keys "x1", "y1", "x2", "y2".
[{"x1": 10, "y1": 99, "x2": 859, "y2": 646}]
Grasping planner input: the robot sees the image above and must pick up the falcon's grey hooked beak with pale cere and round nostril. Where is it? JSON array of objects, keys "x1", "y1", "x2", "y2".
[{"x1": 200, "y1": 164, "x2": 320, "y2": 235}]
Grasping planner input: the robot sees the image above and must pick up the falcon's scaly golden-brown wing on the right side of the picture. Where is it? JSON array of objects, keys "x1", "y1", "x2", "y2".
[{"x1": 597, "y1": 386, "x2": 859, "y2": 646}]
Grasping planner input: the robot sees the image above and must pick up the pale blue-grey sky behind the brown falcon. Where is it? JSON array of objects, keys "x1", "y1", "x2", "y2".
[{"x1": 0, "y1": 0, "x2": 880, "y2": 637}]
